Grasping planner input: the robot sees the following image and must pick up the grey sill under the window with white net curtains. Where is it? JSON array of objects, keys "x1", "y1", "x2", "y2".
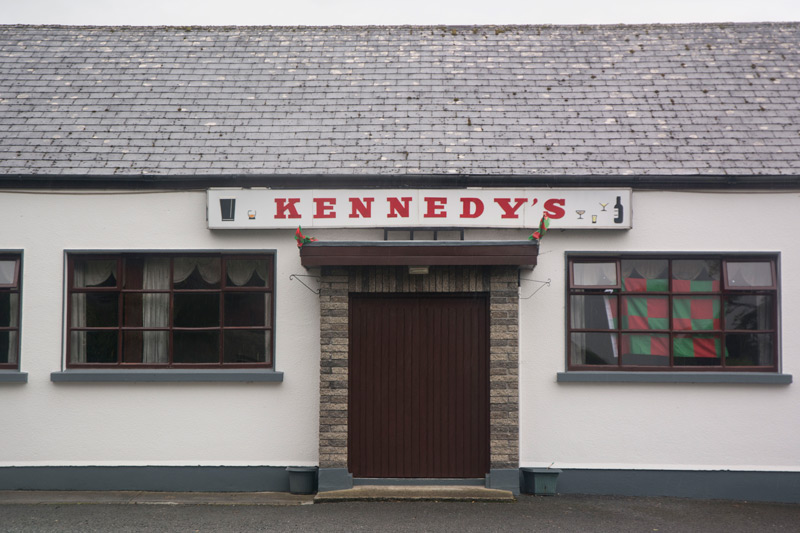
[{"x1": 50, "y1": 368, "x2": 283, "y2": 383}]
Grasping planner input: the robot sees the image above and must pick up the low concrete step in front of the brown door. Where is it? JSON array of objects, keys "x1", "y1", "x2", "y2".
[{"x1": 314, "y1": 485, "x2": 515, "y2": 503}]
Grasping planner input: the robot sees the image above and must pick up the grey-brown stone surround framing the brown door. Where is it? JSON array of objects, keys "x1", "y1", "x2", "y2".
[{"x1": 319, "y1": 266, "x2": 519, "y2": 490}]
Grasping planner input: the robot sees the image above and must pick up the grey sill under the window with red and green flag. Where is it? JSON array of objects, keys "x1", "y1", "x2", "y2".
[{"x1": 556, "y1": 371, "x2": 792, "y2": 385}]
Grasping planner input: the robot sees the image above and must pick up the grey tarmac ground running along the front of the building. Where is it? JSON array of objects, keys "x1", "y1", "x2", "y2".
[{"x1": 0, "y1": 491, "x2": 800, "y2": 533}]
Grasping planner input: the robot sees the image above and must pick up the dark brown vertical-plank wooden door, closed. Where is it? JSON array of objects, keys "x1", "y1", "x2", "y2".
[{"x1": 348, "y1": 294, "x2": 489, "y2": 478}]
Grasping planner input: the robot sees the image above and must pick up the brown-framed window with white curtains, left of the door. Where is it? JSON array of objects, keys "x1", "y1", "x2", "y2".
[{"x1": 67, "y1": 253, "x2": 274, "y2": 368}]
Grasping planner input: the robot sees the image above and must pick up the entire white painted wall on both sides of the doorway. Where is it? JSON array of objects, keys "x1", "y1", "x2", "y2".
[{"x1": 0, "y1": 192, "x2": 800, "y2": 471}]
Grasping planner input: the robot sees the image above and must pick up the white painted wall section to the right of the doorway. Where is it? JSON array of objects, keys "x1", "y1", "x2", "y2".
[{"x1": 520, "y1": 192, "x2": 800, "y2": 471}]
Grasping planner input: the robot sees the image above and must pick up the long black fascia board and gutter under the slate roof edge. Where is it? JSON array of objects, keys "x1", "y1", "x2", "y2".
[{"x1": 0, "y1": 173, "x2": 800, "y2": 190}]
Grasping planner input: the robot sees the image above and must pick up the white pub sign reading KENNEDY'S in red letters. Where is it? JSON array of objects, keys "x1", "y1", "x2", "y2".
[{"x1": 208, "y1": 188, "x2": 631, "y2": 229}]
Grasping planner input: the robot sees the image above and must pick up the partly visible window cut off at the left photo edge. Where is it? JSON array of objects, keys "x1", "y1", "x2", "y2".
[{"x1": 0, "y1": 254, "x2": 22, "y2": 369}]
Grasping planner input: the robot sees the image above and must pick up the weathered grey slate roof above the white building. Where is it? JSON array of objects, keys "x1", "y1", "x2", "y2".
[{"x1": 0, "y1": 23, "x2": 800, "y2": 176}]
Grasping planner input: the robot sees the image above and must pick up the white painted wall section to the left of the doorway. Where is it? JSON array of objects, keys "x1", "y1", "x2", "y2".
[{"x1": 0, "y1": 192, "x2": 319, "y2": 466}]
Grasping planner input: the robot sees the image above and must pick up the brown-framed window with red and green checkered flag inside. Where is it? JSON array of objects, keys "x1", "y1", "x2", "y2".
[{"x1": 567, "y1": 256, "x2": 778, "y2": 371}]
